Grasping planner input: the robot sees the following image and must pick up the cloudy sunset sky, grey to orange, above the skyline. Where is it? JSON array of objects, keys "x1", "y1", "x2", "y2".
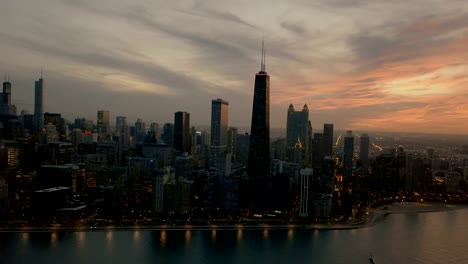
[{"x1": 0, "y1": 0, "x2": 468, "y2": 134}]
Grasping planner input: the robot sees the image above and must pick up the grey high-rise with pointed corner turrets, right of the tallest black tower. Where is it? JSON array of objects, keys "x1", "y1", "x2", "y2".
[{"x1": 286, "y1": 104, "x2": 310, "y2": 164}]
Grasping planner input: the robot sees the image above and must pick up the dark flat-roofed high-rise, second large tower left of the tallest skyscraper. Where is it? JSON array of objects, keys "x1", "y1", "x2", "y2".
[{"x1": 174, "y1": 112, "x2": 190, "y2": 153}]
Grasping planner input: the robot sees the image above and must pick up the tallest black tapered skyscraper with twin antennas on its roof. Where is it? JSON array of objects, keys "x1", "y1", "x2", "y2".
[{"x1": 247, "y1": 43, "x2": 270, "y2": 208}]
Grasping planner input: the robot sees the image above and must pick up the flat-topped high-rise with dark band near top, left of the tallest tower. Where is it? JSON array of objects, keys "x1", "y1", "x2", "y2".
[{"x1": 211, "y1": 99, "x2": 229, "y2": 147}]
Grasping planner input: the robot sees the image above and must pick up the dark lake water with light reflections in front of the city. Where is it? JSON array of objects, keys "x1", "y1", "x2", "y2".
[{"x1": 0, "y1": 209, "x2": 468, "y2": 264}]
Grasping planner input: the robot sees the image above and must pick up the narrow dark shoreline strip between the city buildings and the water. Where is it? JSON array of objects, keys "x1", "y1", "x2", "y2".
[{"x1": 0, "y1": 202, "x2": 468, "y2": 233}]
